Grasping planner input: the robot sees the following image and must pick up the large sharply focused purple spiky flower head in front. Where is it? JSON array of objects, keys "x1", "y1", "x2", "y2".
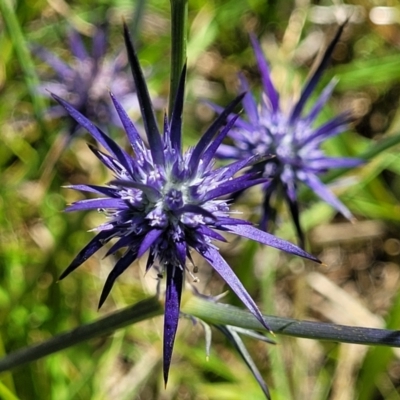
[{"x1": 53, "y1": 27, "x2": 316, "y2": 382}]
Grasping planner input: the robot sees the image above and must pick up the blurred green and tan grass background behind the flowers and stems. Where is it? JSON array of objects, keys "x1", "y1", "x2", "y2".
[{"x1": 0, "y1": 0, "x2": 400, "y2": 400}]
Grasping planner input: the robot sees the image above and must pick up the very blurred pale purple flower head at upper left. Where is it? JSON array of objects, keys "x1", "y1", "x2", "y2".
[{"x1": 32, "y1": 27, "x2": 137, "y2": 133}]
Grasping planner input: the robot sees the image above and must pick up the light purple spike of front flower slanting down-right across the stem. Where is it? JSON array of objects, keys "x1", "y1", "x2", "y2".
[{"x1": 199, "y1": 247, "x2": 271, "y2": 331}]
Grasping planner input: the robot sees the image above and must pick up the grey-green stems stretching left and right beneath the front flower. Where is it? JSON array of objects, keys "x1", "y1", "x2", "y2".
[{"x1": 0, "y1": 293, "x2": 400, "y2": 372}]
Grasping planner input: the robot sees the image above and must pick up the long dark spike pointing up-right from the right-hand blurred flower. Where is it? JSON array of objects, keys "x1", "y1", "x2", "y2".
[{"x1": 289, "y1": 21, "x2": 347, "y2": 123}]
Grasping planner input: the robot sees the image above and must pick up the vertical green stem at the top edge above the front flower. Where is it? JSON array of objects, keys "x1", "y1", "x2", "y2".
[{"x1": 168, "y1": 0, "x2": 188, "y2": 120}]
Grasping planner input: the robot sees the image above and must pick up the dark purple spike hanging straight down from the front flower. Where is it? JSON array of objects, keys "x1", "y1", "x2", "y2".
[{"x1": 163, "y1": 264, "x2": 183, "y2": 385}]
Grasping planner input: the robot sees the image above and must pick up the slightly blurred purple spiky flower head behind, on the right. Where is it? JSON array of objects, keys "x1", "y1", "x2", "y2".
[{"x1": 217, "y1": 25, "x2": 362, "y2": 246}]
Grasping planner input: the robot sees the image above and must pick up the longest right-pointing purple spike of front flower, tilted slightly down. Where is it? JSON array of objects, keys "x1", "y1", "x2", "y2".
[{"x1": 225, "y1": 225, "x2": 321, "y2": 263}]
